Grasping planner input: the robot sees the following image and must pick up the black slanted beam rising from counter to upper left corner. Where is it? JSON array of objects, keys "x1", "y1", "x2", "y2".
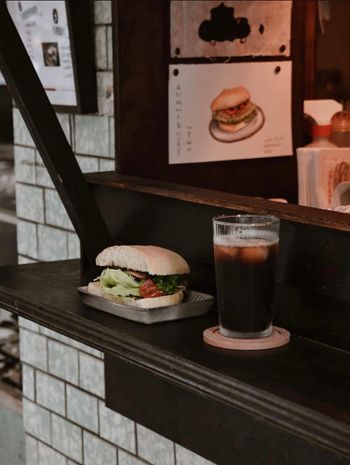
[{"x1": 0, "y1": 2, "x2": 112, "y2": 264}]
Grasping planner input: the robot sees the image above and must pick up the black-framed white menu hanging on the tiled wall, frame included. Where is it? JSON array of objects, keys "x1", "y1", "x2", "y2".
[{"x1": 7, "y1": 0, "x2": 97, "y2": 113}]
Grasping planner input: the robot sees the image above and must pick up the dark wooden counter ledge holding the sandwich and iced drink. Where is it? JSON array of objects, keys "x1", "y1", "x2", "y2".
[{"x1": 0, "y1": 260, "x2": 350, "y2": 465}]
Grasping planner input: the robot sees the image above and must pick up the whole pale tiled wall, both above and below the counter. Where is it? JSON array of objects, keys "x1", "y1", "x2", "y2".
[{"x1": 14, "y1": 1, "x2": 215, "y2": 465}]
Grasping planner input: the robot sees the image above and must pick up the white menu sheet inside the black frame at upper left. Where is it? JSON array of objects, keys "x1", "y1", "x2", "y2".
[{"x1": 7, "y1": 0, "x2": 77, "y2": 106}]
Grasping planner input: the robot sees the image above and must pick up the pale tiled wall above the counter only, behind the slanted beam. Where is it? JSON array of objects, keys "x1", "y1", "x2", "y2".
[{"x1": 13, "y1": 1, "x2": 115, "y2": 263}]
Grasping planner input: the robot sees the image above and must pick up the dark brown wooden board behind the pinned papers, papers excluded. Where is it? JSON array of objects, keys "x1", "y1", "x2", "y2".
[{"x1": 113, "y1": 0, "x2": 305, "y2": 203}]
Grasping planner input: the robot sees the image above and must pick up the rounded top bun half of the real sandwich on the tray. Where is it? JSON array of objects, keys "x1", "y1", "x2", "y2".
[{"x1": 96, "y1": 245, "x2": 190, "y2": 275}]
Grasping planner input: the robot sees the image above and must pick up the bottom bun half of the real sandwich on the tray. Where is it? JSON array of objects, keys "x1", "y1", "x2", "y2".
[{"x1": 88, "y1": 281, "x2": 184, "y2": 308}]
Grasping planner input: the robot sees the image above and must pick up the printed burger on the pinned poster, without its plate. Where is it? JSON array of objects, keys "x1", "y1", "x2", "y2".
[{"x1": 210, "y1": 86, "x2": 257, "y2": 132}]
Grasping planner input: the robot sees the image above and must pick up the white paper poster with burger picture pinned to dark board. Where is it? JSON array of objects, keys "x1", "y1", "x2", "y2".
[{"x1": 169, "y1": 61, "x2": 293, "y2": 164}]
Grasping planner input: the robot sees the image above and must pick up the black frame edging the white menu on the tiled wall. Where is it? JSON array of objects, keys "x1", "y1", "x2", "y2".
[{"x1": 7, "y1": 0, "x2": 97, "y2": 114}]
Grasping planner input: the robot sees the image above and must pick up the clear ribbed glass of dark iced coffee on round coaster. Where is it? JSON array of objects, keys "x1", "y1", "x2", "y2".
[{"x1": 213, "y1": 215, "x2": 279, "y2": 339}]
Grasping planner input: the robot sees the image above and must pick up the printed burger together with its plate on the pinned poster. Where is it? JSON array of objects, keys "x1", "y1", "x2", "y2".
[{"x1": 209, "y1": 86, "x2": 264, "y2": 142}]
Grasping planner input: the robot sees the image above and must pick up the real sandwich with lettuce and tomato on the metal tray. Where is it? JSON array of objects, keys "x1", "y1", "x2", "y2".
[{"x1": 88, "y1": 245, "x2": 190, "y2": 308}]
